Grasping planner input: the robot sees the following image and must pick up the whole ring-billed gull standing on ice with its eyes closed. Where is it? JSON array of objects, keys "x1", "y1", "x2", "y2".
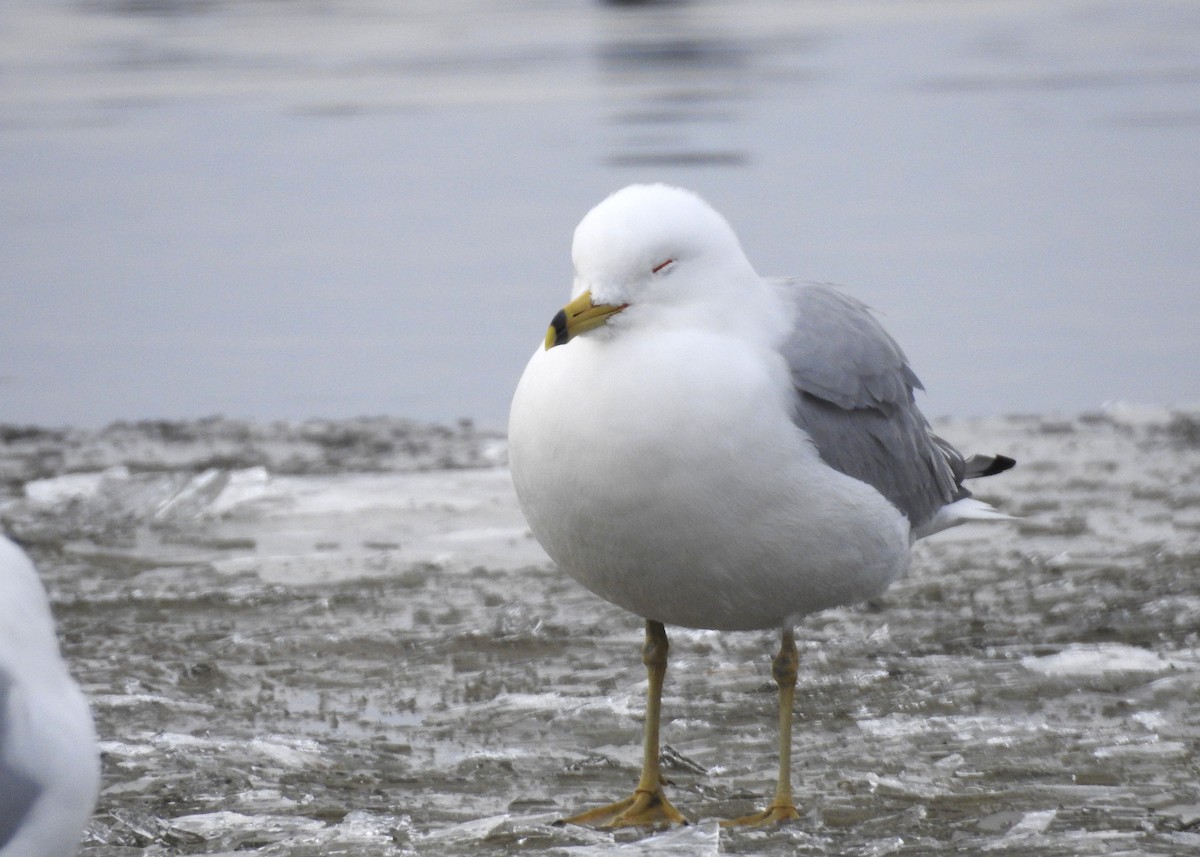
[{"x1": 509, "y1": 185, "x2": 1015, "y2": 827}]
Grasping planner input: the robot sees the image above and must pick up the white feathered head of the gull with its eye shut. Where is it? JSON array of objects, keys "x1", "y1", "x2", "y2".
[{"x1": 571, "y1": 185, "x2": 752, "y2": 305}]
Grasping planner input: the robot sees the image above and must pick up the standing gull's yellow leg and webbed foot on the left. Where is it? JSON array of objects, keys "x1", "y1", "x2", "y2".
[{"x1": 558, "y1": 619, "x2": 688, "y2": 827}]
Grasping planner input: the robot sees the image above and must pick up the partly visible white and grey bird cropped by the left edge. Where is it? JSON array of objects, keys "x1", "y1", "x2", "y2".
[{"x1": 0, "y1": 535, "x2": 100, "y2": 857}]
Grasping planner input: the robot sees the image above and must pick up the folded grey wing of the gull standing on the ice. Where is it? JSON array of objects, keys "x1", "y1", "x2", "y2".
[{"x1": 779, "y1": 282, "x2": 964, "y2": 531}]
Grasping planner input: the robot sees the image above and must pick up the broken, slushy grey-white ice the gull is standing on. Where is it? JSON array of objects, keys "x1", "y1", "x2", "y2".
[{"x1": 0, "y1": 408, "x2": 1200, "y2": 857}]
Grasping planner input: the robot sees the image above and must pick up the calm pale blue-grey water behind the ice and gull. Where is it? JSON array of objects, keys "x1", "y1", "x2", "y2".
[{"x1": 0, "y1": 0, "x2": 1200, "y2": 429}]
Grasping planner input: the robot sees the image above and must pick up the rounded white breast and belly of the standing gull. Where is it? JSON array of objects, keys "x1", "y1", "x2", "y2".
[{"x1": 509, "y1": 332, "x2": 908, "y2": 630}]
